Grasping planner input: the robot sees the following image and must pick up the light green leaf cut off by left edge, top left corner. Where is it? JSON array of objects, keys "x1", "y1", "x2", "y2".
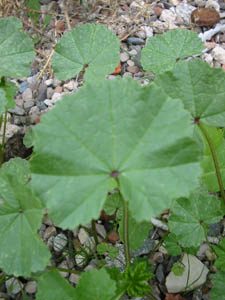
[{"x1": 0, "y1": 17, "x2": 35, "y2": 78}]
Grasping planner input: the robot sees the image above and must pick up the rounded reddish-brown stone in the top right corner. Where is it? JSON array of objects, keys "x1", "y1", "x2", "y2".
[{"x1": 191, "y1": 8, "x2": 220, "y2": 27}]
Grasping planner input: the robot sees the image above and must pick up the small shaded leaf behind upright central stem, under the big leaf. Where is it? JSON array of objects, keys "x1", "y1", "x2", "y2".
[{"x1": 119, "y1": 215, "x2": 152, "y2": 250}]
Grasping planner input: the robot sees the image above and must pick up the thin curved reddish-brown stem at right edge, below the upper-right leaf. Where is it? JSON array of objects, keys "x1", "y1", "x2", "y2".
[{"x1": 198, "y1": 122, "x2": 225, "y2": 203}]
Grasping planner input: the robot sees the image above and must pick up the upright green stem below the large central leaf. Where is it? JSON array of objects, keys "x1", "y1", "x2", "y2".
[{"x1": 123, "y1": 199, "x2": 130, "y2": 267}]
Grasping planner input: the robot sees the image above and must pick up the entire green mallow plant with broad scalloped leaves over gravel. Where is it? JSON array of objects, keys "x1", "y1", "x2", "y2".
[{"x1": 0, "y1": 18, "x2": 225, "y2": 300}]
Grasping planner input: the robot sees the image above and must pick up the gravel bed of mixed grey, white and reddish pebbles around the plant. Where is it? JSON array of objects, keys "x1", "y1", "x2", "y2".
[{"x1": 0, "y1": 0, "x2": 225, "y2": 300}]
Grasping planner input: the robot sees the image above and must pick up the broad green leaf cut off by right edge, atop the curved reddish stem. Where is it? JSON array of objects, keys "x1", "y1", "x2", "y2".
[{"x1": 156, "y1": 59, "x2": 225, "y2": 127}]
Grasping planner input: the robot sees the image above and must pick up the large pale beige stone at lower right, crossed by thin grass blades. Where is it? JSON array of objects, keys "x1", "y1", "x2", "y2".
[{"x1": 166, "y1": 254, "x2": 209, "y2": 293}]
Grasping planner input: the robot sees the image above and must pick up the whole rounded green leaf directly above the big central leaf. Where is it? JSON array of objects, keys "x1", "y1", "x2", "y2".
[{"x1": 52, "y1": 24, "x2": 120, "y2": 81}]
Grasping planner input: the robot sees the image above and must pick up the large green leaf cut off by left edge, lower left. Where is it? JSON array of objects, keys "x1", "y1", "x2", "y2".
[{"x1": 0, "y1": 158, "x2": 50, "y2": 277}]
